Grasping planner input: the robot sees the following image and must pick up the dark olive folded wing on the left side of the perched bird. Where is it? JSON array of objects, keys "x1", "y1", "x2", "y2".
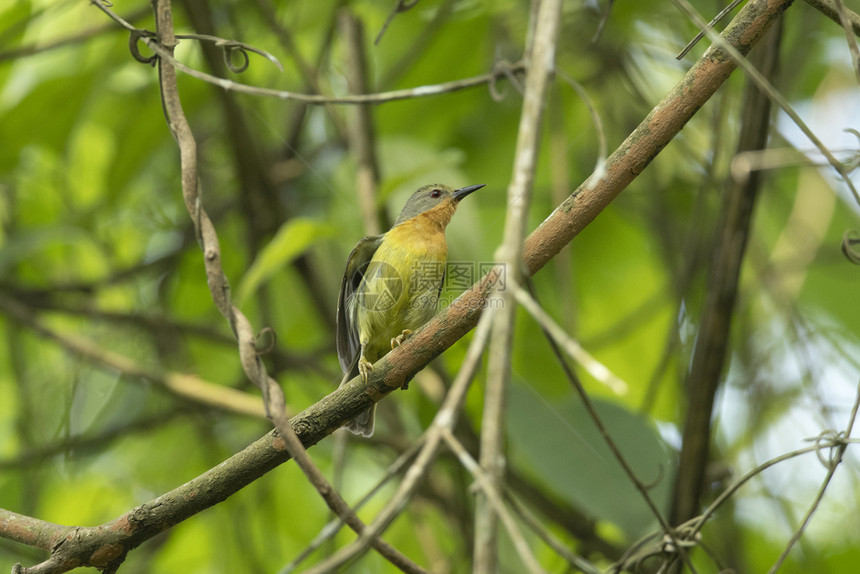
[{"x1": 337, "y1": 235, "x2": 382, "y2": 373}]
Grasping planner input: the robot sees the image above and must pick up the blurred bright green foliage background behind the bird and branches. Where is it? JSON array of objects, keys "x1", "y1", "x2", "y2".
[{"x1": 0, "y1": 0, "x2": 860, "y2": 572}]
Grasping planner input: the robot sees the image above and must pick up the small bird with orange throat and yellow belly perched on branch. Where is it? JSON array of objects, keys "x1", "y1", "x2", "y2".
[{"x1": 336, "y1": 183, "x2": 486, "y2": 437}]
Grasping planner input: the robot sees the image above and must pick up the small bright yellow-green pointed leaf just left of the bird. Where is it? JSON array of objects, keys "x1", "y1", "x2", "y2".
[{"x1": 236, "y1": 217, "x2": 332, "y2": 305}]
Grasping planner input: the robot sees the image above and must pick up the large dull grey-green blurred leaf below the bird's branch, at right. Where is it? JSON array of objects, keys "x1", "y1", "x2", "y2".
[{"x1": 508, "y1": 385, "x2": 674, "y2": 538}]
